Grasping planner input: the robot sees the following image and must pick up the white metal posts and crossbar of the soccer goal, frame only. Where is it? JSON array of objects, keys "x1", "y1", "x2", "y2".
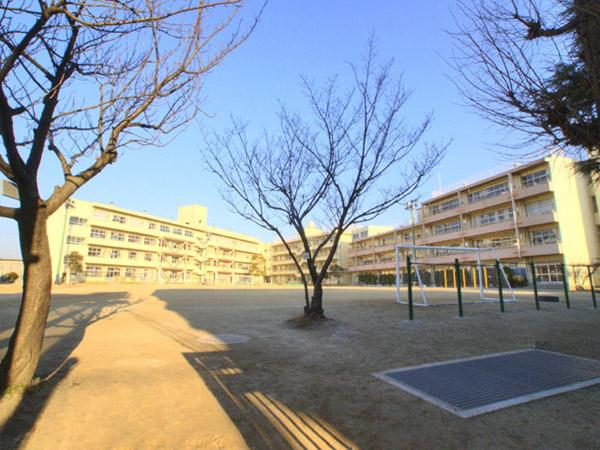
[{"x1": 394, "y1": 244, "x2": 516, "y2": 306}]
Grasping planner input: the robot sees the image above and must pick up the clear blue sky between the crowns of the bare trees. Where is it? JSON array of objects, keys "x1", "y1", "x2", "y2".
[{"x1": 0, "y1": 0, "x2": 524, "y2": 257}]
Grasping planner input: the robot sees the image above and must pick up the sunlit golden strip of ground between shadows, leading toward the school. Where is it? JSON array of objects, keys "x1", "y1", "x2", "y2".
[{"x1": 0, "y1": 286, "x2": 248, "y2": 449}]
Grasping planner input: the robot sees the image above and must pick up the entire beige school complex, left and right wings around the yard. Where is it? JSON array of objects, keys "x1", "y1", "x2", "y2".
[{"x1": 8, "y1": 157, "x2": 600, "y2": 285}]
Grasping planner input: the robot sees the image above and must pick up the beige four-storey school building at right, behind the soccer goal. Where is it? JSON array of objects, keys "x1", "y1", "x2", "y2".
[{"x1": 350, "y1": 157, "x2": 600, "y2": 283}]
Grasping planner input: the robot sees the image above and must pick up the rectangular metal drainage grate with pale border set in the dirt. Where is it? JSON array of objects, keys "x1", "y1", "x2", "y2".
[{"x1": 374, "y1": 349, "x2": 600, "y2": 418}]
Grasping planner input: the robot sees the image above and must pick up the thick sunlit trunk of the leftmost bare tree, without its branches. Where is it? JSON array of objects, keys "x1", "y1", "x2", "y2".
[{"x1": 0, "y1": 199, "x2": 52, "y2": 394}]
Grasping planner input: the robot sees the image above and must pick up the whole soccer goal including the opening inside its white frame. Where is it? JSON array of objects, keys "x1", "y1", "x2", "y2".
[{"x1": 395, "y1": 244, "x2": 516, "y2": 306}]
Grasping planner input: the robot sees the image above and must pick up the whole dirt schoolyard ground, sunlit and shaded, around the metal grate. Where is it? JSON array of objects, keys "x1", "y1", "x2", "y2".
[{"x1": 0, "y1": 285, "x2": 600, "y2": 449}]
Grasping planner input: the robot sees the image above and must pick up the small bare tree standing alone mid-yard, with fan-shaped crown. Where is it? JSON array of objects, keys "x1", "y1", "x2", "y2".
[{"x1": 205, "y1": 39, "x2": 445, "y2": 319}]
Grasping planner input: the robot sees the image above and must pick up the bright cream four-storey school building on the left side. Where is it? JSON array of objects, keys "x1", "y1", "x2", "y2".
[{"x1": 48, "y1": 199, "x2": 268, "y2": 284}]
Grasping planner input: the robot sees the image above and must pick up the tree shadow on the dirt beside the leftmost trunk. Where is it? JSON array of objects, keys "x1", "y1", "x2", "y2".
[{"x1": 0, "y1": 292, "x2": 132, "y2": 449}]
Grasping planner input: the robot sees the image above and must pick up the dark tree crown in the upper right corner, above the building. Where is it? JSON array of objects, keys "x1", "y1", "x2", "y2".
[{"x1": 451, "y1": 0, "x2": 600, "y2": 173}]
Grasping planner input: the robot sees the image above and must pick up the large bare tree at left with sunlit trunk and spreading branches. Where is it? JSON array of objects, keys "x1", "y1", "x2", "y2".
[{"x1": 0, "y1": 0, "x2": 256, "y2": 392}]
